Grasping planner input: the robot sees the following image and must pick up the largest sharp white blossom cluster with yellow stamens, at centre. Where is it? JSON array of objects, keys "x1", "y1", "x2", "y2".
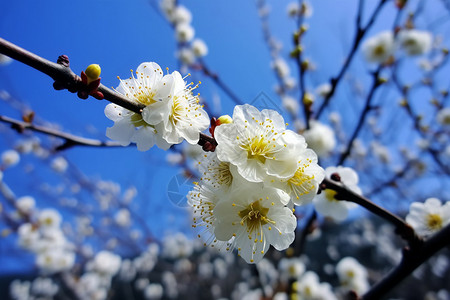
[{"x1": 188, "y1": 104, "x2": 324, "y2": 263}]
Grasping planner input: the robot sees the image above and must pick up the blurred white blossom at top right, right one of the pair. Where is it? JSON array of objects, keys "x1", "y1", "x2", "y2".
[{"x1": 397, "y1": 29, "x2": 433, "y2": 56}]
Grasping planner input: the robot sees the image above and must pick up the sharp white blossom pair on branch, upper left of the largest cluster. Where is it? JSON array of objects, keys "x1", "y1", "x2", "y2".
[{"x1": 105, "y1": 62, "x2": 209, "y2": 151}]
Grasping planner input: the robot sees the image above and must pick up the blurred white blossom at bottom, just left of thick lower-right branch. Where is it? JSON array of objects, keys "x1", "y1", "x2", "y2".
[{"x1": 336, "y1": 257, "x2": 369, "y2": 294}]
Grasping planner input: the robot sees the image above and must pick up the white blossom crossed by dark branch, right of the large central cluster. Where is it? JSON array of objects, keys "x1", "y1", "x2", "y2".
[{"x1": 313, "y1": 167, "x2": 361, "y2": 221}]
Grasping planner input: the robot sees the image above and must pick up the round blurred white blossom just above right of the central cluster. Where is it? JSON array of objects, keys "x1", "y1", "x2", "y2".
[{"x1": 303, "y1": 121, "x2": 336, "y2": 156}]
